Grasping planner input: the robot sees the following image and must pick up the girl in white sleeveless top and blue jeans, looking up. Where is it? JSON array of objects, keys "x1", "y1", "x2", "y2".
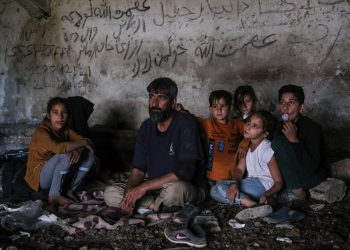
[{"x1": 211, "y1": 111, "x2": 283, "y2": 207}]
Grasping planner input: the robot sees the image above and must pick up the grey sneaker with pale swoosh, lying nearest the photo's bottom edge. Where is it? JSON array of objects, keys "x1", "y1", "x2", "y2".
[{"x1": 164, "y1": 228, "x2": 207, "y2": 248}]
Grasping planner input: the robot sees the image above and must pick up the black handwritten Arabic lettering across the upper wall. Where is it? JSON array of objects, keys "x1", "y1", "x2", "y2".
[{"x1": 0, "y1": 0, "x2": 350, "y2": 93}]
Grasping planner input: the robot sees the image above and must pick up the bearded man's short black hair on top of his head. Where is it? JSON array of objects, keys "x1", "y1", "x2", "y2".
[{"x1": 147, "y1": 77, "x2": 177, "y2": 99}]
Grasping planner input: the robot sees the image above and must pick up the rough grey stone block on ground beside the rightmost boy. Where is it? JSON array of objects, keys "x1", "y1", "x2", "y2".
[{"x1": 310, "y1": 178, "x2": 346, "y2": 203}]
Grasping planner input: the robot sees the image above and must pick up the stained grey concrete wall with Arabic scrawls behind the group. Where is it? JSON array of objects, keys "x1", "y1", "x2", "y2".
[{"x1": 0, "y1": 0, "x2": 350, "y2": 148}]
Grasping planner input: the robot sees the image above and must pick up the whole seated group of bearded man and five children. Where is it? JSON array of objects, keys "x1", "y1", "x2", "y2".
[{"x1": 25, "y1": 78, "x2": 327, "y2": 220}]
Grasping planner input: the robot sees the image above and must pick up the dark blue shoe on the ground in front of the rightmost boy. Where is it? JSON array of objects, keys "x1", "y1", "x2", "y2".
[{"x1": 263, "y1": 207, "x2": 305, "y2": 224}]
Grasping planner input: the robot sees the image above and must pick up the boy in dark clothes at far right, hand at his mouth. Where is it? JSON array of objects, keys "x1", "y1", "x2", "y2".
[{"x1": 271, "y1": 85, "x2": 326, "y2": 202}]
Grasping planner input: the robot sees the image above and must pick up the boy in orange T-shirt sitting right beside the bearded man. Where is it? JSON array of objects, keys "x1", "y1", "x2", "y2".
[{"x1": 178, "y1": 90, "x2": 249, "y2": 186}]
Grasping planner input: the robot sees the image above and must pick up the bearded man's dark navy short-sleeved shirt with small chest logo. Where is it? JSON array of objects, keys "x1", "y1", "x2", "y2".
[{"x1": 133, "y1": 111, "x2": 205, "y2": 186}]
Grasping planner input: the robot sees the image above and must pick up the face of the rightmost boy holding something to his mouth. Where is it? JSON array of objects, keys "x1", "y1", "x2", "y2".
[{"x1": 278, "y1": 92, "x2": 304, "y2": 122}]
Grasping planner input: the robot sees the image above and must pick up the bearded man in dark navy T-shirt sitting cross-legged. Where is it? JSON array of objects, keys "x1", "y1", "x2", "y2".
[{"x1": 119, "y1": 78, "x2": 206, "y2": 213}]
